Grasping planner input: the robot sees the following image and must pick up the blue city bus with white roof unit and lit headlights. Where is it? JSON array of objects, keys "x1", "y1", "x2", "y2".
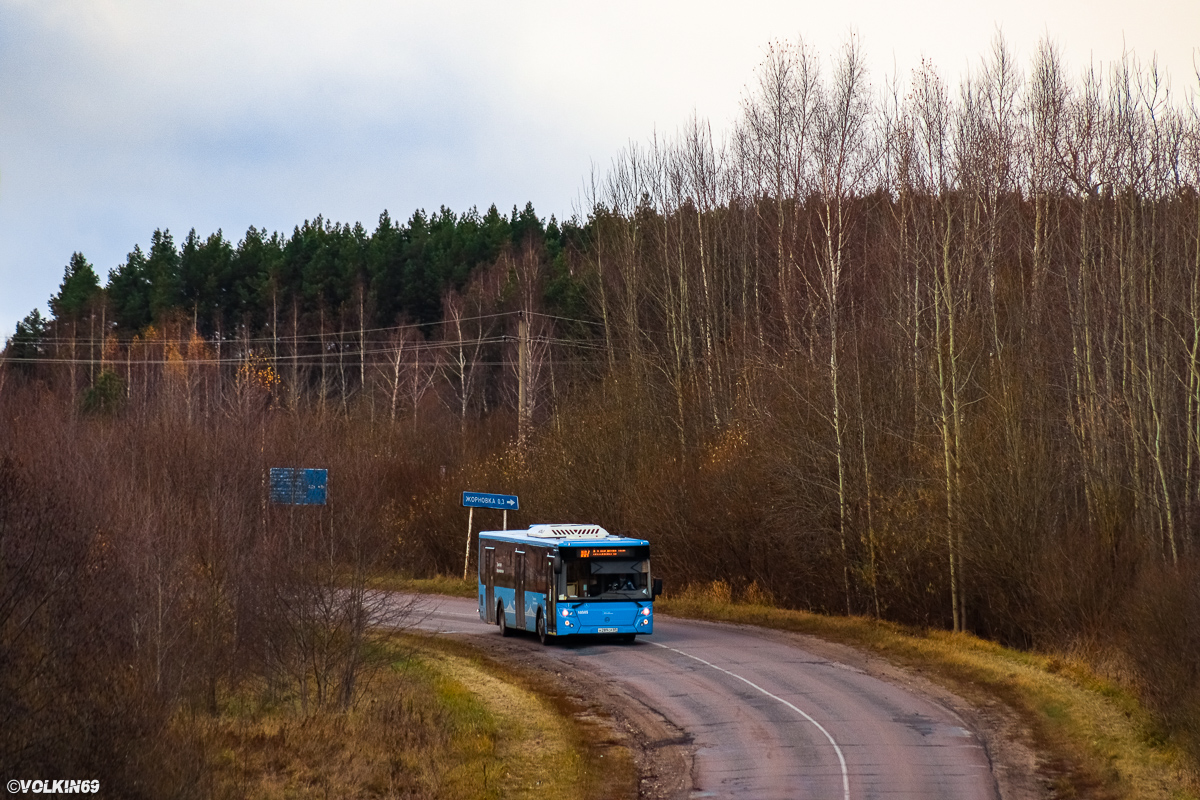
[{"x1": 479, "y1": 524, "x2": 662, "y2": 644}]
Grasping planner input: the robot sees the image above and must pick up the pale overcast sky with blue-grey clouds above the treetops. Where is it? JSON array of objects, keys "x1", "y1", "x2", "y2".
[{"x1": 0, "y1": 0, "x2": 1200, "y2": 336}]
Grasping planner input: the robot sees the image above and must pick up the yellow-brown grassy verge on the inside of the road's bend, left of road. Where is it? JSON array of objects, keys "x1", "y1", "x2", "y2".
[{"x1": 180, "y1": 636, "x2": 636, "y2": 800}]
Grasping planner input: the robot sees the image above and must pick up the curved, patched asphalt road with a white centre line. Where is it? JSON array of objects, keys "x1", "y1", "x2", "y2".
[{"x1": 408, "y1": 597, "x2": 1000, "y2": 800}]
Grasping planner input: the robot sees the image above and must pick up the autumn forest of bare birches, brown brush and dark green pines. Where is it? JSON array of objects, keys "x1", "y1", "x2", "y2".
[{"x1": 0, "y1": 32, "x2": 1200, "y2": 796}]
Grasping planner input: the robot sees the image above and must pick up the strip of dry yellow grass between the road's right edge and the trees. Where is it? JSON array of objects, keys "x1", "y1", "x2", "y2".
[{"x1": 658, "y1": 582, "x2": 1198, "y2": 800}]
